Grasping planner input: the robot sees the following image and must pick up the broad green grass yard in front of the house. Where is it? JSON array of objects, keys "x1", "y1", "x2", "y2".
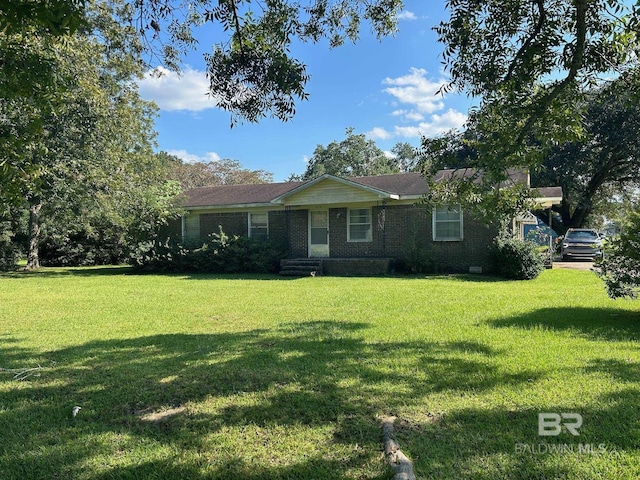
[{"x1": 0, "y1": 268, "x2": 640, "y2": 480}]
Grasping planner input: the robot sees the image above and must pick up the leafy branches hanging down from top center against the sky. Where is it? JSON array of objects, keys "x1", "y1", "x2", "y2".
[{"x1": 129, "y1": 0, "x2": 402, "y2": 125}]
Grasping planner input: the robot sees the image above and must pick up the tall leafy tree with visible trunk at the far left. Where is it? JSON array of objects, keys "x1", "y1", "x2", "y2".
[{"x1": 0, "y1": 2, "x2": 174, "y2": 268}]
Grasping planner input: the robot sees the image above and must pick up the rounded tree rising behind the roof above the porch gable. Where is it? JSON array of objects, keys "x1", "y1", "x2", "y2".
[{"x1": 290, "y1": 128, "x2": 399, "y2": 180}]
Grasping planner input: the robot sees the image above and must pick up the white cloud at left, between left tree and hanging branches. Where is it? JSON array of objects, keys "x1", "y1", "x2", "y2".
[{"x1": 138, "y1": 67, "x2": 216, "y2": 112}]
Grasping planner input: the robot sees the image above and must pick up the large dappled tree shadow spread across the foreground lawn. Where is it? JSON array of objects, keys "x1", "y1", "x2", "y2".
[{"x1": 0, "y1": 318, "x2": 640, "y2": 480}]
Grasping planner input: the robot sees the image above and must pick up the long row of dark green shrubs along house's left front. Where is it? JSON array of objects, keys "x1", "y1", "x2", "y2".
[{"x1": 131, "y1": 231, "x2": 286, "y2": 273}]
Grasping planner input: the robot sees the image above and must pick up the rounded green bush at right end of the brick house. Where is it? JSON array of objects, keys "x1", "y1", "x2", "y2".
[{"x1": 495, "y1": 235, "x2": 544, "y2": 280}]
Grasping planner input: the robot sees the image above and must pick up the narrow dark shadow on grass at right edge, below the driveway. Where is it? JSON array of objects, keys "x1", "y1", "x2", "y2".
[{"x1": 489, "y1": 307, "x2": 640, "y2": 341}]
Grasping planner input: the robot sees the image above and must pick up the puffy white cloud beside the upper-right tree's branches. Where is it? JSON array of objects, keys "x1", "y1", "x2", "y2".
[{"x1": 382, "y1": 68, "x2": 447, "y2": 113}]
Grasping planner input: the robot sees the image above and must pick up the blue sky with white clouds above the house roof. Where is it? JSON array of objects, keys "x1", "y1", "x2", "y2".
[{"x1": 140, "y1": 0, "x2": 471, "y2": 182}]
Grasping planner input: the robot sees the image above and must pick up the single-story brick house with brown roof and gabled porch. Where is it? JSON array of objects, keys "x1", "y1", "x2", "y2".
[{"x1": 170, "y1": 170, "x2": 562, "y2": 274}]
